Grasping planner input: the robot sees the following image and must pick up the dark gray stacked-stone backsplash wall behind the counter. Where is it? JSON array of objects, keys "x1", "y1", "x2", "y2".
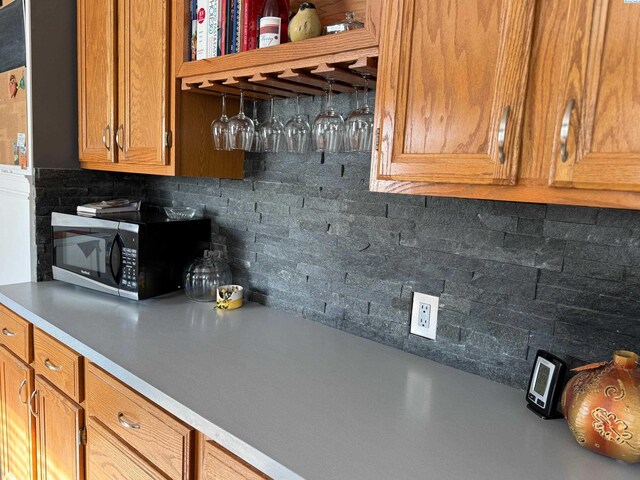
[{"x1": 36, "y1": 95, "x2": 640, "y2": 388}]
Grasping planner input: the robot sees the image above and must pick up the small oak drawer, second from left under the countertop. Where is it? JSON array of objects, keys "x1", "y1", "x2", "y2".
[{"x1": 33, "y1": 328, "x2": 84, "y2": 403}]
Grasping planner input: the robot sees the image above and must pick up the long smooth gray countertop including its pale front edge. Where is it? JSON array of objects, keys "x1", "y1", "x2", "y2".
[{"x1": 0, "y1": 282, "x2": 640, "y2": 480}]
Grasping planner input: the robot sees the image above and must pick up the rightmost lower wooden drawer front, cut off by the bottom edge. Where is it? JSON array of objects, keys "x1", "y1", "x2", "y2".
[{"x1": 200, "y1": 435, "x2": 271, "y2": 480}]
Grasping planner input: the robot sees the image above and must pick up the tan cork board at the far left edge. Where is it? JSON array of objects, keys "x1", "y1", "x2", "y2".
[{"x1": 0, "y1": 67, "x2": 28, "y2": 165}]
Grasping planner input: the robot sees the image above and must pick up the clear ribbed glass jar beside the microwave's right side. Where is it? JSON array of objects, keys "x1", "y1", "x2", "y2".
[{"x1": 184, "y1": 250, "x2": 231, "y2": 302}]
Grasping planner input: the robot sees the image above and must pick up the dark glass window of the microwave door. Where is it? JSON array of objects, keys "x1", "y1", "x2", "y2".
[{"x1": 53, "y1": 227, "x2": 119, "y2": 287}]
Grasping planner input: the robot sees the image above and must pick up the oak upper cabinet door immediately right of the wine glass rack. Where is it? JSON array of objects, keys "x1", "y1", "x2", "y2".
[{"x1": 372, "y1": 0, "x2": 535, "y2": 190}]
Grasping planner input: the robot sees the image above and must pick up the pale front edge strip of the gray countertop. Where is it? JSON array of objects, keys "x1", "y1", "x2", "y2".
[{"x1": 0, "y1": 293, "x2": 303, "y2": 480}]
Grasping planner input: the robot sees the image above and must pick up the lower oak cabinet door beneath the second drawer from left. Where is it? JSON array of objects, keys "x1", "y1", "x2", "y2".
[{"x1": 33, "y1": 375, "x2": 85, "y2": 480}]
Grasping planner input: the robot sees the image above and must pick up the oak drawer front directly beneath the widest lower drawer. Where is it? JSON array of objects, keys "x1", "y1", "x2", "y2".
[{"x1": 87, "y1": 417, "x2": 169, "y2": 480}]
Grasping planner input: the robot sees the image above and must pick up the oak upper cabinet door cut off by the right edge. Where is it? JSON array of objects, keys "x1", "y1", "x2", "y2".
[{"x1": 550, "y1": 0, "x2": 640, "y2": 191}]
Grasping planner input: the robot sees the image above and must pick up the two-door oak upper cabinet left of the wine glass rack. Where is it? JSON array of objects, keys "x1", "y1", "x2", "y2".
[{"x1": 77, "y1": 0, "x2": 243, "y2": 178}]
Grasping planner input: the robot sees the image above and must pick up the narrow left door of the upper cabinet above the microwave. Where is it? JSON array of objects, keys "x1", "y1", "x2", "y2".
[{"x1": 77, "y1": 0, "x2": 117, "y2": 162}]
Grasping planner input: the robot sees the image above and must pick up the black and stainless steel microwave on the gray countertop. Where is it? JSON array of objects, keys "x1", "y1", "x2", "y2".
[{"x1": 51, "y1": 210, "x2": 211, "y2": 300}]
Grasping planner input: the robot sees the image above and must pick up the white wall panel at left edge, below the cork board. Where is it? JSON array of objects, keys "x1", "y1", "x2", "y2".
[{"x1": 0, "y1": 172, "x2": 35, "y2": 285}]
